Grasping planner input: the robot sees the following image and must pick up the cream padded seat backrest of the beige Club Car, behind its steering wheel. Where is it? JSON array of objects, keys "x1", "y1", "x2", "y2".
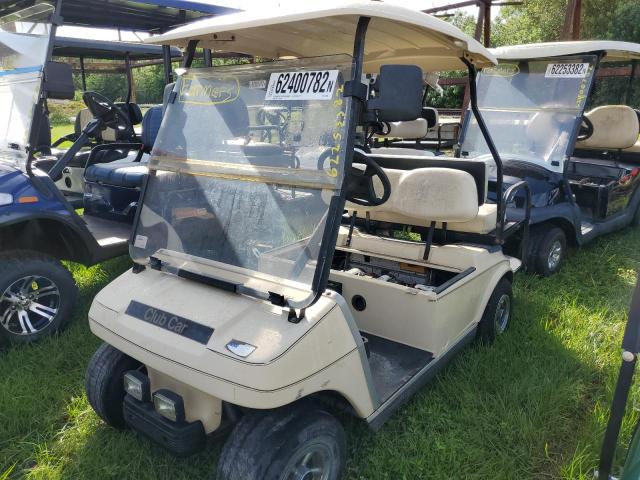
[{"x1": 347, "y1": 168, "x2": 479, "y2": 225}]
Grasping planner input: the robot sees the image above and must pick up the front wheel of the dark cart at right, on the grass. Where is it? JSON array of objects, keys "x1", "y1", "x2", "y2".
[{"x1": 529, "y1": 226, "x2": 567, "y2": 277}]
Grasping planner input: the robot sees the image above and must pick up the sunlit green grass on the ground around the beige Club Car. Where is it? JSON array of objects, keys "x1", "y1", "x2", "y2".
[{"x1": 0, "y1": 230, "x2": 640, "y2": 480}]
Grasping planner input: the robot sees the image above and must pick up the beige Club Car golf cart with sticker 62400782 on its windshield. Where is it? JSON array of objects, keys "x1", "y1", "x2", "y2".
[{"x1": 86, "y1": 2, "x2": 520, "y2": 480}]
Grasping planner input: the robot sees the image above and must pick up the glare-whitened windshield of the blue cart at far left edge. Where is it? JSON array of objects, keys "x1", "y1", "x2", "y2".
[{"x1": 0, "y1": 3, "x2": 54, "y2": 168}]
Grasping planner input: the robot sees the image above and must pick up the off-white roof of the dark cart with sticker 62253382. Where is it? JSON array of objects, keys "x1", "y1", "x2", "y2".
[{"x1": 490, "y1": 40, "x2": 640, "y2": 62}]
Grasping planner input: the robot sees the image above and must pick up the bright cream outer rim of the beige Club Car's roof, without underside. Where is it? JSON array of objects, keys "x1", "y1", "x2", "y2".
[{"x1": 145, "y1": 1, "x2": 497, "y2": 70}]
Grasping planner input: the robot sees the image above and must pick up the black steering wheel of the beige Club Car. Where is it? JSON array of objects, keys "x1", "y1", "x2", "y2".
[{"x1": 345, "y1": 150, "x2": 391, "y2": 207}]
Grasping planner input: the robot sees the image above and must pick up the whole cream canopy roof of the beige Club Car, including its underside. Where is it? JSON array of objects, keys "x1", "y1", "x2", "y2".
[{"x1": 147, "y1": 1, "x2": 496, "y2": 73}]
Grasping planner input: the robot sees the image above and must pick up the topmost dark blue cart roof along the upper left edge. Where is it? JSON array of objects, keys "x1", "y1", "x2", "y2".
[{"x1": 0, "y1": 0, "x2": 236, "y2": 33}]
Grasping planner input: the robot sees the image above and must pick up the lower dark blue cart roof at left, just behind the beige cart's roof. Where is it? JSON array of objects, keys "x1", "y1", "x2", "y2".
[{"x1": 53, "y1": 37, "x2": 182, "y2": 60}]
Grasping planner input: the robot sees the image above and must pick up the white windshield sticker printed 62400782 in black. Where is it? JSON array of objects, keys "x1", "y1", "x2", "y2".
[{"x1": 264, "y1": 70, "x2": 338, "y2": 100}]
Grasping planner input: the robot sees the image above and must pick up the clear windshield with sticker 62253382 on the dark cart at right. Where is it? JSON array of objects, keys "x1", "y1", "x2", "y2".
[{"x1": 461, "y1": 56, "x2": 596, "y2": 172}]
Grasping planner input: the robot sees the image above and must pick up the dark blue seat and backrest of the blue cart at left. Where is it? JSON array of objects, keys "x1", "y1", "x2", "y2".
[{"x1": 84, "y1": 106, "x2": 162, "y2": 188}]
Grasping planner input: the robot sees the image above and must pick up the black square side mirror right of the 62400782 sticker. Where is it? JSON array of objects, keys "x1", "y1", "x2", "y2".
[{"x1": 367, "y1": 65, "x2": 423, "y2": 122}]
